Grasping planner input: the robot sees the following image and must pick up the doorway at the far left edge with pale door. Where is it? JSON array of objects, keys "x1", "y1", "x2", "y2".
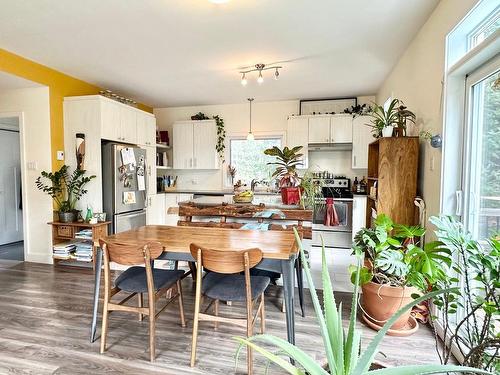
[{"x1": 0, "y1": 116, "x2": 24, "y2": 261}]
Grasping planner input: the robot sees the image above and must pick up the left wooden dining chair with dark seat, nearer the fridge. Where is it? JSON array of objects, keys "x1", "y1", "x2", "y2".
[{"x1": 99, "y1": 239, "x2": 186, "y2": 362}]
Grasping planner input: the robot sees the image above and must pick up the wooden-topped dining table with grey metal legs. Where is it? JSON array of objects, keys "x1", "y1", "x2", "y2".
[{"x1": 90, "y1": 225, "x2": 298, "y2": 344}]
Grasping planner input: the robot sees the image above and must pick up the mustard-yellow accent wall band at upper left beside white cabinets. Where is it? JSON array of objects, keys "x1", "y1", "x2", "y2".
[{"x1": 0, "y1": 48, "x2": 153, "y2": 170}]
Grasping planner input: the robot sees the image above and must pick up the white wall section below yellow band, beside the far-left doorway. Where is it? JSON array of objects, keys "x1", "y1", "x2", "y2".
[{"x1": 0, "y1": 87, "x2": 52, "y2": 263}]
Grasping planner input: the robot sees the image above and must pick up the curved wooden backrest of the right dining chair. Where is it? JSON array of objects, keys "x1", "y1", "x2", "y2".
[{"x1": 189, "y1": 243, "x2": 262, "y2": 273}]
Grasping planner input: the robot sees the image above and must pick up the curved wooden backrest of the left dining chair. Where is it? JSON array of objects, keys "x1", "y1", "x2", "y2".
[{"x1": 99, "y1": 239, "x2": 163, "y2": 266}]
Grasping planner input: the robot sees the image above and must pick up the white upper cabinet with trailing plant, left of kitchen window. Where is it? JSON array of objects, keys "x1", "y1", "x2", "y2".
[{"x1": 172, "y1": 120, "x2": 219, "y2": 169}]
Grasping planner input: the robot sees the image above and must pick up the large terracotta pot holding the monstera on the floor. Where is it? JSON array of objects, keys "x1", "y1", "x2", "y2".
[{"x1": 361, "y1": 282, "x2": 418, "y2": 330}]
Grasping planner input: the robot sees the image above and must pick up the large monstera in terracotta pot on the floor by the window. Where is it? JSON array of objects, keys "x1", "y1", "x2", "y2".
[{"x1": 351, "y1": 214, "x2": 451, "y2": 335}]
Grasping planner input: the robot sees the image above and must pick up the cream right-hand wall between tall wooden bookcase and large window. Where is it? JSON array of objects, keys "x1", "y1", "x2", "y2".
[{"x1": 377, "y1": 0, "x2": 477, "y2": 223}]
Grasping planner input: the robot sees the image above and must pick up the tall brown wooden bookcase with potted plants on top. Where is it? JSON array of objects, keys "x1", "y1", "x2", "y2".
[{"x1": 366, "y1": 137, "x2": 419, "y2": 227}]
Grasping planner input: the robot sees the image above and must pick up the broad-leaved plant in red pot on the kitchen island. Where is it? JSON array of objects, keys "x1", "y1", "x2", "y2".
[{"x1": 264, "y1": 146, "x2": 303, "y2": 204}]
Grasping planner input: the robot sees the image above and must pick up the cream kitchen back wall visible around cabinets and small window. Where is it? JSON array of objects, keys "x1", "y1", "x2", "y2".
[{"x1": 154, "y1": 96, "x2": 375, "y2": 189}]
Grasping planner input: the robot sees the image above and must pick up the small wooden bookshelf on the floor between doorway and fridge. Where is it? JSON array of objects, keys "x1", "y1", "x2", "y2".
[{"x1": 48, "y1": 221, "x2": 111, "y2": 269}]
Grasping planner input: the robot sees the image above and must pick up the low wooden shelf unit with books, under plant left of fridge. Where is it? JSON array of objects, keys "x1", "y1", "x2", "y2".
[{"x1": 48, "y1": 221, "x2": 111, "y2": 269}]
